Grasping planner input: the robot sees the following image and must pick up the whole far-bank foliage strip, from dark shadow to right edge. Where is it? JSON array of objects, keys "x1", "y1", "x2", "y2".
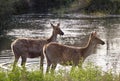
[{"x1": 27, "y1": 0, "x2": 120, "y2": 14}]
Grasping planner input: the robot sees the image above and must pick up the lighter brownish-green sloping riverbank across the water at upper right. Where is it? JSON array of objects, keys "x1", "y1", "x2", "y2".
[{"x1": 54, "y1": 0, "x2": 120, "y2": 15}]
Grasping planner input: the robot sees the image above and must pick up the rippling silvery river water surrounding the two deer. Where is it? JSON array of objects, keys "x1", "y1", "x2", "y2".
[{"x1": 0, "y1": 14, "x2": 120, "y2": 73}]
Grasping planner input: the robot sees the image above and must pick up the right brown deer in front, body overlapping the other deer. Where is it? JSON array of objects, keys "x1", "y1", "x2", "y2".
[{"x1": 43, "y1": 32, "x2": 105, "y2": 72}]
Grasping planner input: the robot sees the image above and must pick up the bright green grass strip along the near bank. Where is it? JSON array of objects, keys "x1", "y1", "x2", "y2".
[{"x1": 0, "y1": 66, "x2": 120, "y2": 81}]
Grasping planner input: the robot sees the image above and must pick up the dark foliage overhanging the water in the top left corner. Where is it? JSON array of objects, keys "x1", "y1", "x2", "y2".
[{"x1": 0, "y1": 0, "x2": 28, "y2": 34}]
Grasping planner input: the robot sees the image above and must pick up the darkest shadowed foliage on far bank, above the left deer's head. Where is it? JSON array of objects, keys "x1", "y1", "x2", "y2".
[{"x1": 31, "y1": 0, "x2": 74, "y2": 13}]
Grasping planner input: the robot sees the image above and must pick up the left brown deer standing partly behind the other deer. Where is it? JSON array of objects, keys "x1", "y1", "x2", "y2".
[{"x1": 11, "y1": 23, "x2": 64, "y2": 70}]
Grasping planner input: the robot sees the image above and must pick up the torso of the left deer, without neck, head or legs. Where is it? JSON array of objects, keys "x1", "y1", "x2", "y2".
[{"x1": 12, "y1": 38, "x2": 48, "y2": 58}]
